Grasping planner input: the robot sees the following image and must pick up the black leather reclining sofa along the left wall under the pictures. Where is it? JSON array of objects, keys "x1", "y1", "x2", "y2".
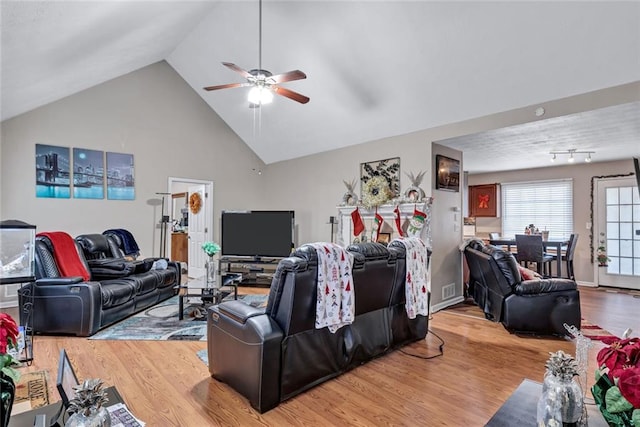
[{"x1": 18, "y1": 234, "x2": 181, "y2": 337}]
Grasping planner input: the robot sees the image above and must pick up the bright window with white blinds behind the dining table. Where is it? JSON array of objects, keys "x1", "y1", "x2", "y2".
[{"x1": 501, "y1": 179, "x2": 573, "y2": 239}]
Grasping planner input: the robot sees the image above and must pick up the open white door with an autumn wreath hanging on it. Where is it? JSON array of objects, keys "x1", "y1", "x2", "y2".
[{"x1": 187, "y1": 184, "x2": 209, "y2": 278}]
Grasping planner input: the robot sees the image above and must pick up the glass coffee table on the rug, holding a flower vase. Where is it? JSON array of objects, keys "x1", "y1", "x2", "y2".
[{"x1": 176, "y1": 273, "x2": 242, "y2": 320}]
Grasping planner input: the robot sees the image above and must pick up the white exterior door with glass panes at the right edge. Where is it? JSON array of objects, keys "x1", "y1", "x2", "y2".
[{"x1": 593, "y1": 176, "x2": 640, "y2": 289}]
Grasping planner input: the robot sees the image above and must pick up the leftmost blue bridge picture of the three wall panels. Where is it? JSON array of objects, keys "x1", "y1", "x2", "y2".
[{"x1": 36, "y1": 144, "x2": 71, "y2": 199}]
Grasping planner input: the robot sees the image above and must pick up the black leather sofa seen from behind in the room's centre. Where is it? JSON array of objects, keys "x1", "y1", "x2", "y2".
[{"x1": 207, "y1": 243, "x2": 428, "y2": 412}]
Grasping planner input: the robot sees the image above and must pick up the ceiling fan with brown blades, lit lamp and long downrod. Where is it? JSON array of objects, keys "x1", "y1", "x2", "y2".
[{"x1": 204, "y1": 0, "x2": 309, "y2": 107}]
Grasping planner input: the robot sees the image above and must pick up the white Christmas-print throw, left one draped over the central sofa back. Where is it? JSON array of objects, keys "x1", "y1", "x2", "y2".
[{"x1": 309, "y1": 243, "x2": 355, "y2": 333}]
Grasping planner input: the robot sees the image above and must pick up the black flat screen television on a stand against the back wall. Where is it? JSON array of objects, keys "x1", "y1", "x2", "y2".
[{"x1": 221, "y1": 211, "x2": 295, "y2": 259}]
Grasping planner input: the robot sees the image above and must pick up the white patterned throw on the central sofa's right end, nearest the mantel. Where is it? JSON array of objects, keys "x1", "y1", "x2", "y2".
[{"x1": 394, "y1": 237, "x2": 430, "y2": 319}]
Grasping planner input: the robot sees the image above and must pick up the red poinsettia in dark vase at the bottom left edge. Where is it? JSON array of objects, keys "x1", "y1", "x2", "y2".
[{"x1": 0, "y1": 313, "x2": 20, "y2": 427}]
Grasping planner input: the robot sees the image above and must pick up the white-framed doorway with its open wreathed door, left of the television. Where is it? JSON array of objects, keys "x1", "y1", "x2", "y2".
[{"x1": 167, "y1": 177, "x2": 213, "y2": 278}]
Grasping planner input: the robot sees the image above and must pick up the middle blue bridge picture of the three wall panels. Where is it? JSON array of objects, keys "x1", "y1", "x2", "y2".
[{"x1": 73, "y1": 148, "x2": 104, "y2": 199}]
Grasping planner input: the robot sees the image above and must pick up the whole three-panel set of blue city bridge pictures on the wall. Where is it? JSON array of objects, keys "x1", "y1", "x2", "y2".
[{"x1": 36, "y1": 144, "x2": 135, "y2": 200}]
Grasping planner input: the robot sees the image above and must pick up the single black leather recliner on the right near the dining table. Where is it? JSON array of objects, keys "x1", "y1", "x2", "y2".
[{"x1": 464, "y1": 241, "x2": 581, "y2": 336}]
